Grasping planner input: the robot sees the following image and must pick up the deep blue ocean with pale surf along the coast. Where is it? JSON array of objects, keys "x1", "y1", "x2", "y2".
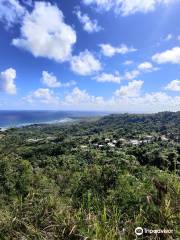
[{"x1": 0, "y1": 110, "x2": 105, "y2": 128}]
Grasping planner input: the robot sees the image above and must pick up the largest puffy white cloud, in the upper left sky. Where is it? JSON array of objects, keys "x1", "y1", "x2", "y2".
[{"x1": 12, "y1": 2, "x2": 76, "y2": 62}]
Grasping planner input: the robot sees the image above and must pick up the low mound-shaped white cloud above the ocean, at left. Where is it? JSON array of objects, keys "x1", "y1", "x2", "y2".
[{"x1": 23, "y1": 88, "x2": 59, "y2": 105}]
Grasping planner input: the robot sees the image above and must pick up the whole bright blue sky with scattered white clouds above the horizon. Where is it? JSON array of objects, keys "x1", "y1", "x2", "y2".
[{"x1": 0, "y1": 0, "x2": 180, "y2": 113}]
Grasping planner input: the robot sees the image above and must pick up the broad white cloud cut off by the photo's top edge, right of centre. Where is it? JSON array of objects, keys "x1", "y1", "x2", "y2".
[{"x1": 82, "y1": 0, "x2": 179, "y2": 16}]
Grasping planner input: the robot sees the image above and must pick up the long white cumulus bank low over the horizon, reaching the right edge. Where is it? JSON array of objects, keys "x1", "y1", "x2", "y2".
[{"x1": 60, "y1": 86, "x2": 180, "y2": 112}]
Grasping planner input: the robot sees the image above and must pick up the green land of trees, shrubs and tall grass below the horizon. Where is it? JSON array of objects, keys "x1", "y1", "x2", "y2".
[{"x1": 0, "y1": 112, "x2": 180, "y2": 240}]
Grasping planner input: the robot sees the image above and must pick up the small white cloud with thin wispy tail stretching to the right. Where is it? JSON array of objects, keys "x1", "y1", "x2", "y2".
[{"x1": 41, "y1": 71, "x2": 76, "y2": 88}]
